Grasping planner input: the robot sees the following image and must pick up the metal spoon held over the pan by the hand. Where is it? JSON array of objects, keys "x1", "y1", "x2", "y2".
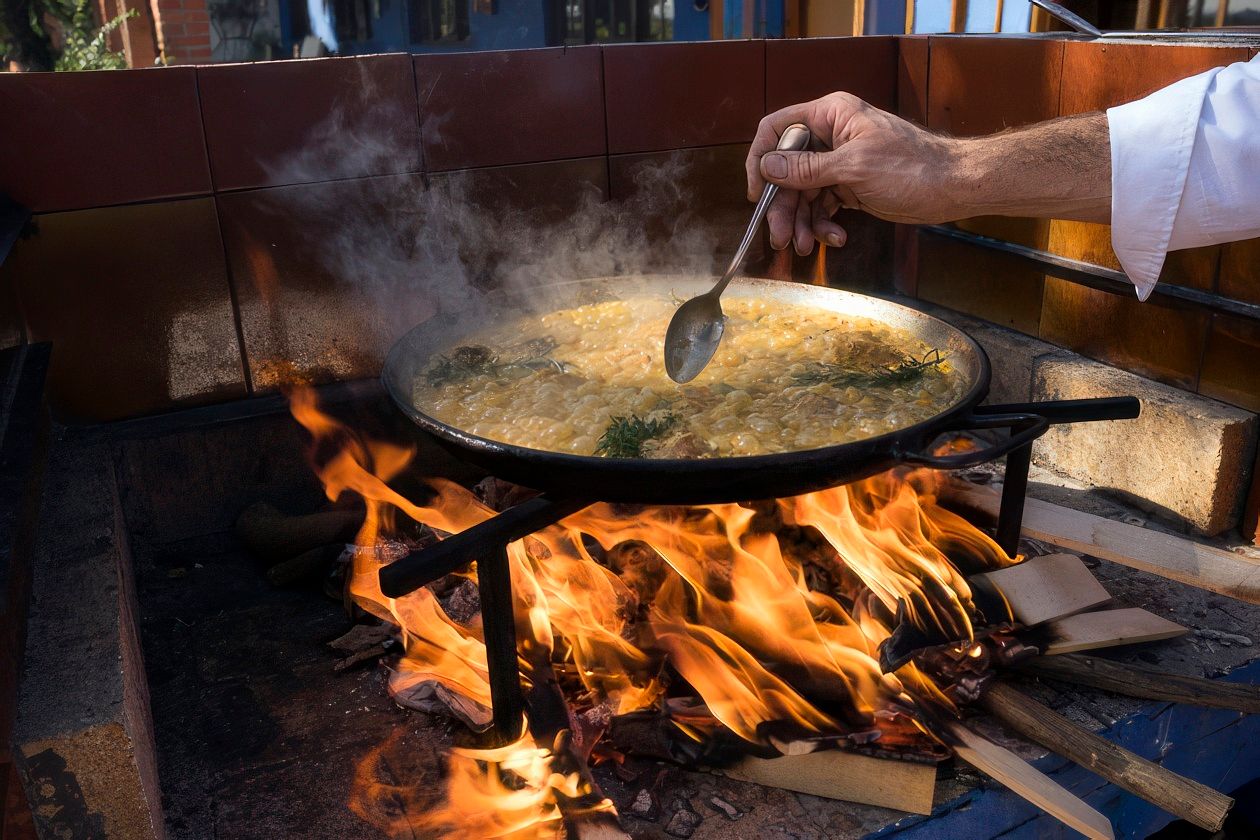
[{"x1": 665, "y1": 122, "x2": 810, "y2": 383}]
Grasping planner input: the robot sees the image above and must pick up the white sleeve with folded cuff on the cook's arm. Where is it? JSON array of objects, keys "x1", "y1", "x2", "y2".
[{"x1": 1106, "y1": 55, "x2": 1260, "y2": 300}]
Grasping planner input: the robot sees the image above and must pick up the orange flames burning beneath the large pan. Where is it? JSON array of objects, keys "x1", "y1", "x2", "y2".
[{"x1": 291, "y1": 389, "x2": 1011, "y2": 837}]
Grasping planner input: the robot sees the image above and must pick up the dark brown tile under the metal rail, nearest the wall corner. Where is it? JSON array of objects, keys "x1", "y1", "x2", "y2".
[{"x1": 917, "y1": 236, "x2": 1045, "y2": 335}]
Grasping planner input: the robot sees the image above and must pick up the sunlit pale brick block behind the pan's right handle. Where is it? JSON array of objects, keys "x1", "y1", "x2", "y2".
[{"x1": 1032, "y1": 354, "x2": 1257, "y2": 535}]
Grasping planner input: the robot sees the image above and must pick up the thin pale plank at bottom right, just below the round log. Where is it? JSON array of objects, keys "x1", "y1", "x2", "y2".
[{"x1": 939, "y1": 720, "x2": 1115, "y2": 840}]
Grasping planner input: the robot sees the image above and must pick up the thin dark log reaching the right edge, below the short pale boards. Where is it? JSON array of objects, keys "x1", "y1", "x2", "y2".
[{"x1": 1017, "y1": 654, "x2": 1260, "y2": 714}]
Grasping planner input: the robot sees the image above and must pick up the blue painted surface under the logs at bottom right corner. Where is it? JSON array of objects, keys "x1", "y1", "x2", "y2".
[{"x1": 868, "y1": 660, "x2": 1260, "y2": 840}]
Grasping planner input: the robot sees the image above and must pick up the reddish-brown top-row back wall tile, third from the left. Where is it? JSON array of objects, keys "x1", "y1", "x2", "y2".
[{"x1": 413, "y1": 47, "x2": 607, "y2": 171}]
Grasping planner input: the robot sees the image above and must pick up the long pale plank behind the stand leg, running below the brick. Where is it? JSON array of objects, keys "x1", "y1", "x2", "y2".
[{"x1": 945, "y1": 482, "x2": 1260, "y2": 603}]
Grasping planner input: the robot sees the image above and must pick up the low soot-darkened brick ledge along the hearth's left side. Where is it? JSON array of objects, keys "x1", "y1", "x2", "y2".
[{"x1": 14, "y1": 445, "x2": 164, "y2": 840}]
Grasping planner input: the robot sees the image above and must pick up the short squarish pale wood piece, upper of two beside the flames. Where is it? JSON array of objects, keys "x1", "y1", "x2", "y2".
[{"x1": 971, "y1": 554, "x2": 1111, "y2": 627}]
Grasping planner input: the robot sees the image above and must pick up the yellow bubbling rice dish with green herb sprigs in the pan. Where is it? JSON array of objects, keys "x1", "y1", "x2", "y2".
[{"x1": 412, "y1": 297, "x2": 968, "y2": 458}]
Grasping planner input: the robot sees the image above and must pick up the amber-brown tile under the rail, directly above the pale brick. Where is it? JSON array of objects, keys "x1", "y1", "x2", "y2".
[{"x1": 1041, "y1": 277, "x2": 1207, "y2": 389}]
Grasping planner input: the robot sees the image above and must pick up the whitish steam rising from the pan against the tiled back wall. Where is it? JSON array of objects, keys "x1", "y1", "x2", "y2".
[{"x1": 244, "y1": 66, "x2": 745, "y2": 377}]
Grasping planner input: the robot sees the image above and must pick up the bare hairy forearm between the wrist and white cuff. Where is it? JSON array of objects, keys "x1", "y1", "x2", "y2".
[{"x1": 949, "y1": 113, "x2": 1111, "y2": 223}]
